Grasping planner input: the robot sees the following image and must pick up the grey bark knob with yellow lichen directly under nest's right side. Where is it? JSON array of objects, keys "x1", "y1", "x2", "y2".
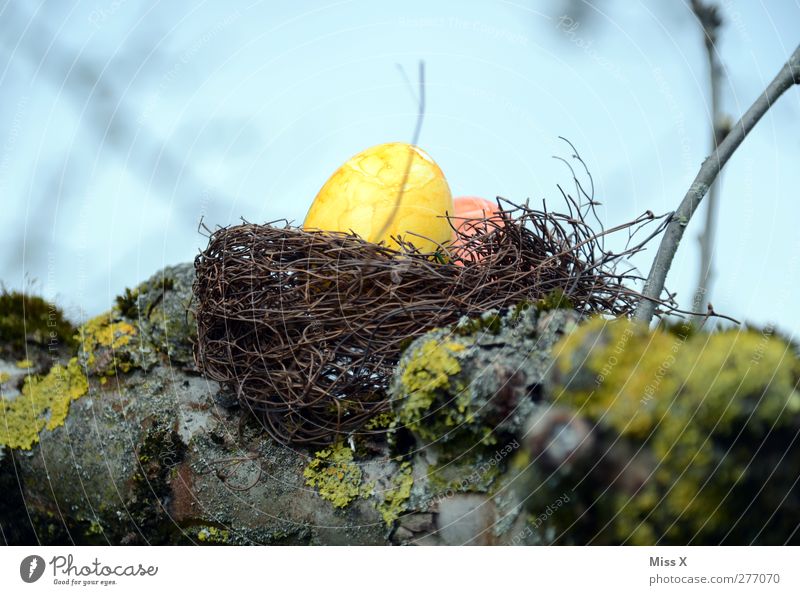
[{"x1": 390, "y1": 301, "x2": 564, "y2": 447}]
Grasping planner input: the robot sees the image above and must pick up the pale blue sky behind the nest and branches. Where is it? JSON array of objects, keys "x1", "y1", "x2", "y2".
[{"x1": 0, "y1": 0, "x2": 800, "y2": 335}]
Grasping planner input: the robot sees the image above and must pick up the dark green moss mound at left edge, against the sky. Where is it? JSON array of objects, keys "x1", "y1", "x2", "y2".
[{"x1": 0, "y1": 290, "x2": 75, "y2": 356}]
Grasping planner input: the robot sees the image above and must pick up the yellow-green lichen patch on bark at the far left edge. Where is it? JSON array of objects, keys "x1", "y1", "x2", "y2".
[{"x1": 0, "y1": 358, "x2": 89, "y2": 450}]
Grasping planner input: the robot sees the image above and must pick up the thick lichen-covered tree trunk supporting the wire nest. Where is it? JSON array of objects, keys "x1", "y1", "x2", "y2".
[{"x1": 0, "y1": 265, "x2": 800, "y2": 545}]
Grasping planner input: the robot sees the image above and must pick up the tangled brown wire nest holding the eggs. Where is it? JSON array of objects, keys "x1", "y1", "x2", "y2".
[{"x1": 194, "y1": 196, "x2": 663, "y2": 445}]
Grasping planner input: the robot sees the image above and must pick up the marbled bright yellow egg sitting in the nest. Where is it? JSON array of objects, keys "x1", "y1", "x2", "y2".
[{"x1": 303, "y1": 143, "x2": 453, "y2": 252}]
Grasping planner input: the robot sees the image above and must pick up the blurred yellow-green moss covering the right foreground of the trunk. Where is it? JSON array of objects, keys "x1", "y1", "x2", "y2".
[{"x1": 553, "y1": 320, "x2": 800, "y2": 545}]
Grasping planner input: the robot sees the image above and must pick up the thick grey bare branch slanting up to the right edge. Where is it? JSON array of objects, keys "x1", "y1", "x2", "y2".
[{"x1": 634, "y1": 46, "x2": 800, "y2": 323}]
